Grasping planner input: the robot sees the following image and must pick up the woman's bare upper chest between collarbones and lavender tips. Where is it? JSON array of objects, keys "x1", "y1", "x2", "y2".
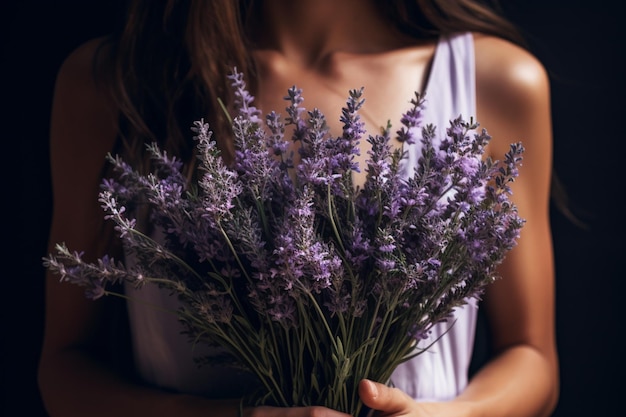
[{"x1": 255, "y1": 46, "x2": 434, "y2": 184}]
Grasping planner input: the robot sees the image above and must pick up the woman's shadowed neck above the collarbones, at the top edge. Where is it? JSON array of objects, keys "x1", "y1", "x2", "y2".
[{"x1": 251, "y1": 0, "x2": 414, "y2": 66}]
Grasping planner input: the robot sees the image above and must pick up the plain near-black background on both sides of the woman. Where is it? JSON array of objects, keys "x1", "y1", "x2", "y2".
[{"x1": 0, "y1": 0, "x2": 626, "y2": 417}]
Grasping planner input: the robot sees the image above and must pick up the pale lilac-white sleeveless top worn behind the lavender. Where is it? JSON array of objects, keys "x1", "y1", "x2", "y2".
[{"x1": 126, "y1": 33, "x2": 478, "y2": 400}]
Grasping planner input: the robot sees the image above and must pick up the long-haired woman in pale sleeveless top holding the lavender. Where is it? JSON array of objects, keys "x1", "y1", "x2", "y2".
[{"x1": 39, "y1": 0, "x2": 558, "y2": 417}]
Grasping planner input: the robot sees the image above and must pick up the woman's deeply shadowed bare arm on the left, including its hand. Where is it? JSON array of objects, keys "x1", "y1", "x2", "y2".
[{"x1": 39, "y1": 41, "x2": 347, "y2": 417}]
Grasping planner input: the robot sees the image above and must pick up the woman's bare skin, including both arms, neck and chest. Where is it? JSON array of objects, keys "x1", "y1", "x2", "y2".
[{"x1": 39, "y1": 0, "x2": 558, "y2": 417}]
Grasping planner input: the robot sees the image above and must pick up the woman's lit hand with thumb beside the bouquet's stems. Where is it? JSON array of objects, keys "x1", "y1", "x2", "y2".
[{"x1": 359, "y1": 379, "x2": 469, "y2": 417}]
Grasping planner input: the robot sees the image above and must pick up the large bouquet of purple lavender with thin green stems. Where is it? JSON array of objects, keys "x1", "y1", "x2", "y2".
[{"x1": 44, "y1": 71, "x2": 523, "y2": 415}]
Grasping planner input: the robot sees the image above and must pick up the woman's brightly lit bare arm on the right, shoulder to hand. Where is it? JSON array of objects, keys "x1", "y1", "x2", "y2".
[{"x1": 360, "y1": 35, "x2": 559, "y2": 417}]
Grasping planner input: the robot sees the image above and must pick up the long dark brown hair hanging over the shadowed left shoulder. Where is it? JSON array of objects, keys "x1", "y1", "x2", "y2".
[{"x1": 99, "y1": 0, "x2": 254, "y2": 170}]
